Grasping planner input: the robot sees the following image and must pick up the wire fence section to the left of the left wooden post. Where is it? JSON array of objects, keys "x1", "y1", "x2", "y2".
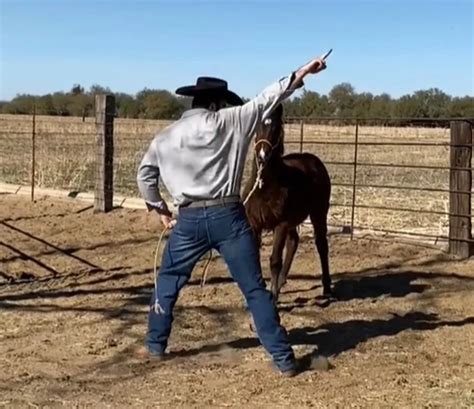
[{"x1": 0, "y1": 112, "x2": 95, "y2": 199}]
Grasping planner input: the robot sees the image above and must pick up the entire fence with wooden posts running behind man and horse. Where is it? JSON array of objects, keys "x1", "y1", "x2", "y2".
[{"x1": 0, "y1": 95, "x2": 474, "y2": 256}]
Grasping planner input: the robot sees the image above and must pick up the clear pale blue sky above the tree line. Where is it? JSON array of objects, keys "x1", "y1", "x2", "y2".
[{"x1": 0, "y1": 0, "x2": 474, "y2": 99}]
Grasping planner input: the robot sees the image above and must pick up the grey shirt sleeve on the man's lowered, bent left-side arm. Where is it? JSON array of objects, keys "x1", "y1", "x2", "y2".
[{"x1": 137, "y1": 139, "x2": 169, "y2": 213}]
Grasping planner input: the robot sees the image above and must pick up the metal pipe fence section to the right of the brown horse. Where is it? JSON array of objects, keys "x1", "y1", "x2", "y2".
[{"x1": 286, "y1": 113, "x2": 474, "y2": 250}]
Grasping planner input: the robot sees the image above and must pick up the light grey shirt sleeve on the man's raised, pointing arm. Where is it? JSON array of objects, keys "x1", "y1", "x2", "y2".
[{"x1": 217, "y1": 73, "x2": 303, "y2": 137}]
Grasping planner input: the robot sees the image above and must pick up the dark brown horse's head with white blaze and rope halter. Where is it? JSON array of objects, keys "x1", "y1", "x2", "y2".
[{"x1": 254, "y1": 104, "x2": 284, "y2": 165}]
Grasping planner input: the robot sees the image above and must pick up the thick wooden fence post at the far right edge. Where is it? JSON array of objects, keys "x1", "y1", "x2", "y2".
[{"x1": 449, "y1": 121, "x2": 473, "y2": 258}]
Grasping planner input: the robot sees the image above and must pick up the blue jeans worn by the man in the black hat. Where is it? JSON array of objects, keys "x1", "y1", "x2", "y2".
[{"x1": 146, "y1": 203, "x2": 294, "y2": 371}]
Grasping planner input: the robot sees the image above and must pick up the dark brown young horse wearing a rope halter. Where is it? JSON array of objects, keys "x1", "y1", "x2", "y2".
[{"x1": 244, "y1": 104, "x2": 332, "y2": 303}]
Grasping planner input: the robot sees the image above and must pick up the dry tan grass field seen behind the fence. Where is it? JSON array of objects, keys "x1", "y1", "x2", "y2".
[{"x1": 0, "y1": 115, "x2": 470, "y2": 239}]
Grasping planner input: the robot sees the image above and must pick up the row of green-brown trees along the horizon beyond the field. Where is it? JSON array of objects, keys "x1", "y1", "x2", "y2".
[{"x1": 0, "y1": 83, "x2": 474, "y2": 119}]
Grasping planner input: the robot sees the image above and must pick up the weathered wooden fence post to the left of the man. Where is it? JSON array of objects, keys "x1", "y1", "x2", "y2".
[{"x1": 94, "y1": 95, "x2": 115, "y2": 213}]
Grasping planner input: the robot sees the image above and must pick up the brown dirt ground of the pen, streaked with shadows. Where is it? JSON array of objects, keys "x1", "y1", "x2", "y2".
[{"x1": 0, "y1": 195, "x2": 474, "y2": 408}]
